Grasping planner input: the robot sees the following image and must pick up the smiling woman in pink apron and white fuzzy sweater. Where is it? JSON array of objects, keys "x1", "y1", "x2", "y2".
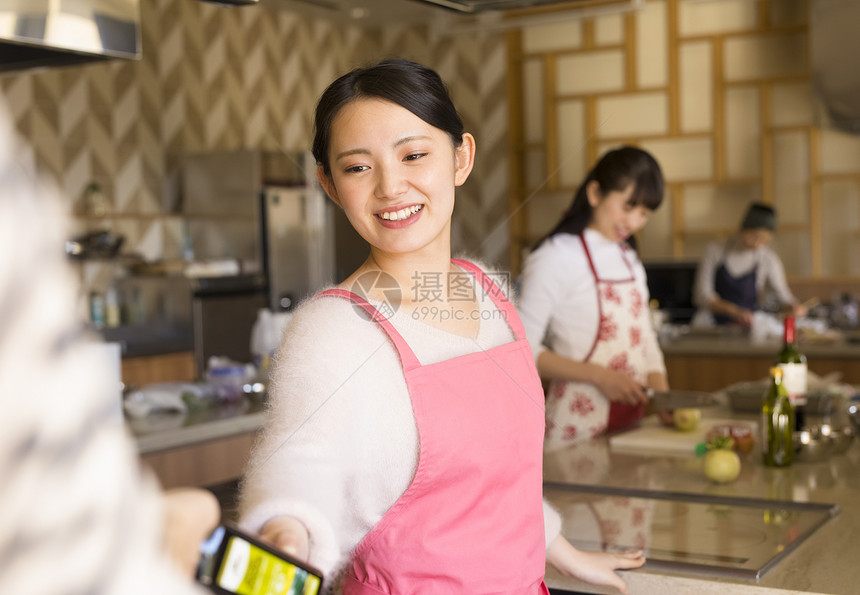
[{"x1": 235, "y1": 60, "x2": 644, "y2": 595}]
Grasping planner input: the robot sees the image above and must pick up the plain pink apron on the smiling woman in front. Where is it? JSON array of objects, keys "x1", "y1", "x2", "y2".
[{"x1": 322, "y1": 260, "x2": 549, "y2": 595}]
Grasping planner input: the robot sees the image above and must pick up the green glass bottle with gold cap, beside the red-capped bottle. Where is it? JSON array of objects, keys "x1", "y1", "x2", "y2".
[{"x1": 761, "y1": 366, "x2": 794, "y2": 467}]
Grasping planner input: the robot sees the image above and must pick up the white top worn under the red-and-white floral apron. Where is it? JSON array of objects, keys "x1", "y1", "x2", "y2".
[{"x1": 517, "y1": 229, "x2": 666, "y2": 374}]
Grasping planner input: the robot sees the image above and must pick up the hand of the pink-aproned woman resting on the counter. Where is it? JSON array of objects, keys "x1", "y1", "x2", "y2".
[{"x1": 546, "y1": 535, "x2": 645, "y2": 595}]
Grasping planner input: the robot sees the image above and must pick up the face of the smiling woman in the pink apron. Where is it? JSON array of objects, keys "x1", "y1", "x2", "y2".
[{"x1": 317, "y1": 98, "x2": 475, "y2": 254}]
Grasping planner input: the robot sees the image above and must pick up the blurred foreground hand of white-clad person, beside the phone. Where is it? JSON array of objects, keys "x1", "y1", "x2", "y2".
[{"x1": 164, "y1": 488, "x2": 221, "y2": 577}]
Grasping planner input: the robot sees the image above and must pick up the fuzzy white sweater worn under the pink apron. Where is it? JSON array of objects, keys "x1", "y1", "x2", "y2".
[{"x1": 240, "y1": 266, "x2": 561, "y2": 585}]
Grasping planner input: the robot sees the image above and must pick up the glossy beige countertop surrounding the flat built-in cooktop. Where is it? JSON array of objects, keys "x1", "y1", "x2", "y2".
[{"x1": 544, "y1": 409, "x2": 860, "y2": 595}]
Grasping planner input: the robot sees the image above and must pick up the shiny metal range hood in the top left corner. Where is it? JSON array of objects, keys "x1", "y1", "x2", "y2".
[{"x1": 0, "y1": 0, "x2": 141, "y2": 73}]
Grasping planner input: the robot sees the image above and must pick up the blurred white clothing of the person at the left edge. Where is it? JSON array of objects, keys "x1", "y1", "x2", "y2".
[{"x1": 0, "y1": 107, "x2": 204, "y2": 595}]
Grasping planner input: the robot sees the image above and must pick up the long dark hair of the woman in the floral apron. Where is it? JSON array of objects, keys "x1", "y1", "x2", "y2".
[{"x1": 534, "y1": 146, "x2": 663, "y2": 249}]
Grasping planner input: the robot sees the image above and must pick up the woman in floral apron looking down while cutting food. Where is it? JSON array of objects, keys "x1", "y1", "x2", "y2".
[{"x1": 519, "y1": 147, "x2": 668, "y2": 449}]
